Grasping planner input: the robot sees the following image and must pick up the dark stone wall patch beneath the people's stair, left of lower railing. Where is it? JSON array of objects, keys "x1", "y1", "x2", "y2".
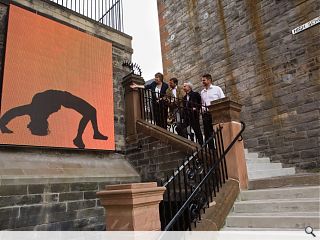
[{"x1": 126, "y1": 133, "x2": 187, "y2": 183}]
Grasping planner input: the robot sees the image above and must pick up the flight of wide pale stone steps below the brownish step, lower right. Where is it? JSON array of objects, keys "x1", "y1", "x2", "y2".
[{"x1": 224, "y1": 186, "x2": 320, "y2": 231}]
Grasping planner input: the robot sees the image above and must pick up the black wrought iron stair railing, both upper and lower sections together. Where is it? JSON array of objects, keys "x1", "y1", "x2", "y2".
[{"x1": 140, "y1": 89, "x2": 245, "y2": 231}]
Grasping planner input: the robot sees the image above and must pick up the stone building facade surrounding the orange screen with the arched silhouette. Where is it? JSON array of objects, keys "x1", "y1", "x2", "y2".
[{"x1": 0, "y1": 0, "x2": 140, "y2": 230}]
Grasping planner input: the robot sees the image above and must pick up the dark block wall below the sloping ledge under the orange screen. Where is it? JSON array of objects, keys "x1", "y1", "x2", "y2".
[{"x1": 0, "y1": 182, "x2": 124, "y2": 231}]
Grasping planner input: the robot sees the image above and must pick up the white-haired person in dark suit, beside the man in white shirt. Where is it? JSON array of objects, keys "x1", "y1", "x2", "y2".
[{"x1": 177, "y1": 83, "x2": 203, "y2": 145}]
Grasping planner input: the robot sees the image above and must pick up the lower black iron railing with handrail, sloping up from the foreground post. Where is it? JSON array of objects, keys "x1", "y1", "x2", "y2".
[{"x1": 160, "y1": 122, "x2": 245, "y2": 231}]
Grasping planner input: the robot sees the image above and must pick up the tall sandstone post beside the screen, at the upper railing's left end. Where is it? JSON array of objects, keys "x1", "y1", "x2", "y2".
[{"x1": 122, "y1": 74, "x2": 144, "y2": 142}]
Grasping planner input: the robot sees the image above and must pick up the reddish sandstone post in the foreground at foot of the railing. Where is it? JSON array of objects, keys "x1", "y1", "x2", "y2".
[{"x1": 97, "y1": 182, "x2": 166, "y2": 231}]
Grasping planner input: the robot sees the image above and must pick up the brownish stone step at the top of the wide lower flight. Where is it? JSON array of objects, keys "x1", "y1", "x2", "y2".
[{"x1": 249, "y1": 173, "x2": 320, "y2": 189}]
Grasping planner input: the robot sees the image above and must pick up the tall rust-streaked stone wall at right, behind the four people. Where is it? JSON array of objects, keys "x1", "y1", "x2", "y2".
[{"x1": 158, "y1": 0, "x2": 320, "y2": 169}]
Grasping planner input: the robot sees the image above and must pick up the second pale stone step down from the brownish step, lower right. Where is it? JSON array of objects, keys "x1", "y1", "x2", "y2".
[{"x1": 233, "y1": 198, "x2": 320, "y2": 213}]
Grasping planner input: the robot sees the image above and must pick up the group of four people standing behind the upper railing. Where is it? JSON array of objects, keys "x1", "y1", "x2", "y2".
[{"x1": 131, "y1": 73, "x2": 225, "y2": 147}]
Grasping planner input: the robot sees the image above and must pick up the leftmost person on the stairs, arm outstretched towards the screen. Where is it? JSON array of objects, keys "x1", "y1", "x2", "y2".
[{"x1": 130, "y1": 73, "x2": 168, "y2": 129}]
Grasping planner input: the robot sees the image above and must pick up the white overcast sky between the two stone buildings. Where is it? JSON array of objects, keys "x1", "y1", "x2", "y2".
[{"x1": 122, "y1": 0, "x2": 163, "y2": 81}]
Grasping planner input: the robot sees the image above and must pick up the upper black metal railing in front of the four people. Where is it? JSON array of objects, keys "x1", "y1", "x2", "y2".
[{"x1": 140, "y1": 89, "x2": 209, "y2": 145}]
